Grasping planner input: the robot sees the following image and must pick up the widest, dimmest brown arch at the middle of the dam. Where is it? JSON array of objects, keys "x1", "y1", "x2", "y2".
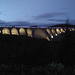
[{"x1": 34, "y1": 29, "x2": 50, "y2": 41}]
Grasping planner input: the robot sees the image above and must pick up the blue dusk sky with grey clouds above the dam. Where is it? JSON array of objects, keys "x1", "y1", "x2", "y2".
[{"x1": 0, "y1": 0, "x2": 75, "y2": 25}]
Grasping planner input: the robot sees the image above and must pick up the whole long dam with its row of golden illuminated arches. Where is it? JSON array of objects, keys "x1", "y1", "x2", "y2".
[{"x1": 0, "y1": 27, "x2": 75, "y2": 41}]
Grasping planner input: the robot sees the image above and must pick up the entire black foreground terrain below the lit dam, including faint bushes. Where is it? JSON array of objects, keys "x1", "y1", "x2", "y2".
[{"x1": 0, "y1": 32, "x2": 75, "y2": 75}]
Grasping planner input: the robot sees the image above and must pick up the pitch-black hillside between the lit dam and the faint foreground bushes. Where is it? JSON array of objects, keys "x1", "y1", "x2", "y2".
[{"x1": 0, "y1": 32, "x2": 75, "y2": 65}]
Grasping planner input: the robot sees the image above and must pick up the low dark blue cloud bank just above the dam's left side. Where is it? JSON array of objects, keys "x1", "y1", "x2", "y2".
[{"x1": 0, "y1": 20, "x2": 55, "y2": 27}]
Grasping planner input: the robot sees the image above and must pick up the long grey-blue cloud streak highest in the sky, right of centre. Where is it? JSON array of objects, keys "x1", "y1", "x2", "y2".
[{"x1": 33, "y1": 12, "x2": 67, "y2": 20}]
